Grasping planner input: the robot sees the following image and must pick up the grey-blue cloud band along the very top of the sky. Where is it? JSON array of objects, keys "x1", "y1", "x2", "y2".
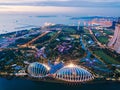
[{"x1": 0, "y1": 0, "x2": 120, "y2": 7}]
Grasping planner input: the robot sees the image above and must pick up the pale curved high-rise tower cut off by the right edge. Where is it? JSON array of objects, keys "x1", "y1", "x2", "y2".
[{"x1": 108, "y1": 18, "x2": 120, "y2": 53}]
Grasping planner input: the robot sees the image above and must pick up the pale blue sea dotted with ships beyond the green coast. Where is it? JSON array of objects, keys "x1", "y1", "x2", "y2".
[{"x1": 0, "y1": 14, "x2": 78, "y2": 34}]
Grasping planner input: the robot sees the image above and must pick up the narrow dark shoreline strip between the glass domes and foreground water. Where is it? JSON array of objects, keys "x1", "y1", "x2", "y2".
[{"x1": 0, "y1": 75, "x2": 120, "y2": 85}]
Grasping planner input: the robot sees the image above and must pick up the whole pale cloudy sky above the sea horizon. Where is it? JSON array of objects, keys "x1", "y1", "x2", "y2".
[{"x1": 0, "y1": 0, "x2": 120, "y2": 16}]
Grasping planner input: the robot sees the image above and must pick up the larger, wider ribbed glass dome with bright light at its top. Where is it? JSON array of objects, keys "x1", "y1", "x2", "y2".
[{"x1": 55, "y1": 66, "x2": 94, "y2": 82}]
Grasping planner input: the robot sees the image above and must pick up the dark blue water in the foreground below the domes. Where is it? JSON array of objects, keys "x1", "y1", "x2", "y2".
[{"x1": 0, "y1": 78, "x2": 120, "y2": 90}]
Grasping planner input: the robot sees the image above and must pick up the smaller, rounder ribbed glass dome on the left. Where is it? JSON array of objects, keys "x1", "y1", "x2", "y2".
[{"x1": 27, "y1": 62, "x2": 49, "y2": 78}]
